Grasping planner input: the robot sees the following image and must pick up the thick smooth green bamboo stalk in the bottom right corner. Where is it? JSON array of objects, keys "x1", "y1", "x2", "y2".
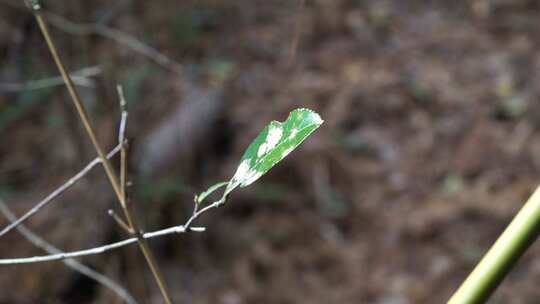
[{"x1": 448, "y1": 186, "x2": 540, "y2": 304}]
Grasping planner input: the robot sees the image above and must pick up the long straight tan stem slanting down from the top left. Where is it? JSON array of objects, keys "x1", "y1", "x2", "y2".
[{"x1": 32, "y1": 8, "x2": 172, "y2": 304}]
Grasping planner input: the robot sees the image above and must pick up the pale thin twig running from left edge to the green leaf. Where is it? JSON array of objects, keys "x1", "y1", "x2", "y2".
[{"x1": 0, "y1": 199, "x2": 221, "y2": 265}]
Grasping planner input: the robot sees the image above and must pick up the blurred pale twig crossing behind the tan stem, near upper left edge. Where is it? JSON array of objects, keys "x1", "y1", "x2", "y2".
[{"x1": 0, "y1": 66, "x2": 101, "y2": 93}]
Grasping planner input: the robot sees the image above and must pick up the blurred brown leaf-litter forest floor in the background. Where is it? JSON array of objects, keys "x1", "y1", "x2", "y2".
[{"x1": 0, "y1": 0, "x2": 540, "y2": 304}]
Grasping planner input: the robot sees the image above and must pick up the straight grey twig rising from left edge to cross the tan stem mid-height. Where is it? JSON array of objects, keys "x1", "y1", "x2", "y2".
[{"x1": 0, "y1": 145, "x2": 121, "y2": 237}]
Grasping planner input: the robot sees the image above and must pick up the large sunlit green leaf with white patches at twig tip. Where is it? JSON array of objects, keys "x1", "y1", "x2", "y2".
[{"x1": 224, "y1": 109, "x2": 323, "y2": 197}]
